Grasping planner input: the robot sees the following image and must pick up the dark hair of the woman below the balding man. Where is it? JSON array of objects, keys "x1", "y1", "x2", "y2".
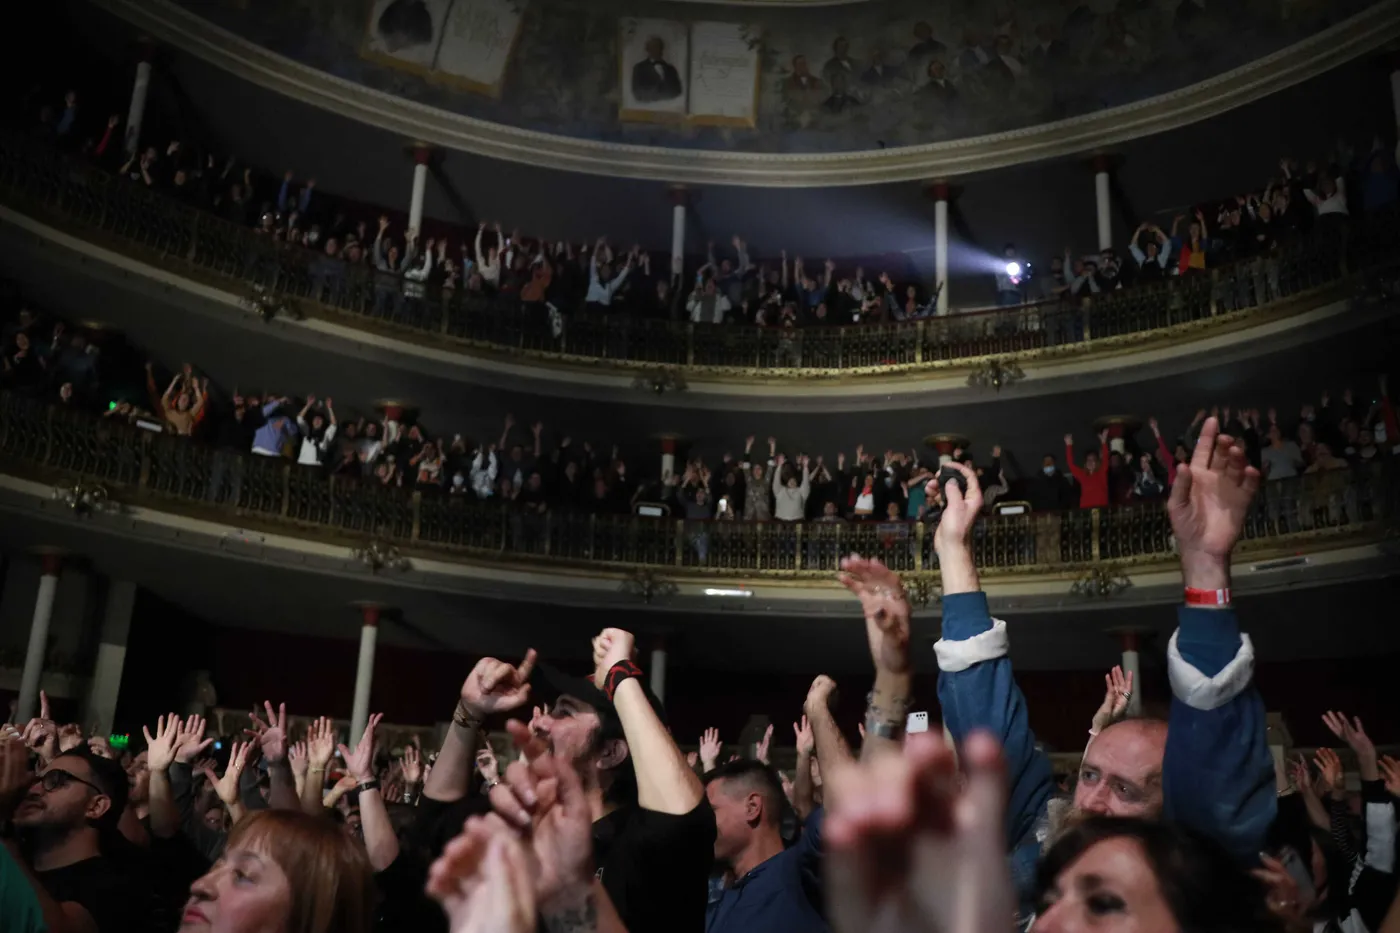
[{"x1": 1036, "y1": 817, "x2": 1287, "y2": 933}]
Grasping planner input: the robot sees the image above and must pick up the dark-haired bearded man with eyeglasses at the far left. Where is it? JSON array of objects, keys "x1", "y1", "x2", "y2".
[{"x1": 13, "y1": 745, "x2": 150, "y2": 933}]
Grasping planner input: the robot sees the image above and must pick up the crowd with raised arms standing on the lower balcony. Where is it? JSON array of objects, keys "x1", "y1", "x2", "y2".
[{"x1": 0, "y1": 294, "x2": 1400, "y2": 535}]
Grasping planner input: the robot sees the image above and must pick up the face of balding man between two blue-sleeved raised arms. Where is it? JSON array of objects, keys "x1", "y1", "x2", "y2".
[{"x1": 1074, "y1": 719, "x2": 1166, "y2": 817}]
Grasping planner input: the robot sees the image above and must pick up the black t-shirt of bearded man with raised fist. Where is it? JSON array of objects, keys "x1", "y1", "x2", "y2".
[{"x1": 594, "y1": 799, "x2": 715, "y2": 933}]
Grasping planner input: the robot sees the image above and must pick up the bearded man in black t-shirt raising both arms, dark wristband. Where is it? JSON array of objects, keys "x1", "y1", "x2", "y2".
[{"x1": 423, "y1": 629, "x2": 715, "y2": 933}]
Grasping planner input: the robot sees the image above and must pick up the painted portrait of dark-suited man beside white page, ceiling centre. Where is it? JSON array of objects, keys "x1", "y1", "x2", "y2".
[{"x1": 617, "y1": 18, "x2": 690, "y2": 120}]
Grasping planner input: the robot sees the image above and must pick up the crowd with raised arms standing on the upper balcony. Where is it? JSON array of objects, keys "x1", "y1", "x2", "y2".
[{"x1": 28, "y1": 75, "x2": 1400, "y2": 332}]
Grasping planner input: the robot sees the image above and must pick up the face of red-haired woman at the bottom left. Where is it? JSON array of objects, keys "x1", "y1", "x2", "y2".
[{"x1": 179, "y1": 848, "x2": 291, "y2": 933}]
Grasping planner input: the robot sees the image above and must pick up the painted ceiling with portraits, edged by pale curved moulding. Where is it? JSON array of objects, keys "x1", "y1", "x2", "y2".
[{"x1": 97, "y1": 0, "x2": 1400, "y2": 188}]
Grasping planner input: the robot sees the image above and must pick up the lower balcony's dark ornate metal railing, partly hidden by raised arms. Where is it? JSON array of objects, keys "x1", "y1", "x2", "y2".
[{"x1": 0, "y1": 394, "x2": 1400, "y2": 577}]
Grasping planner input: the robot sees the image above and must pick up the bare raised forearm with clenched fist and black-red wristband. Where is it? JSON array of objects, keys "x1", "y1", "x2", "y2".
[{"x1": 594, "y1": 629, "x2": 704, "y2": 814}]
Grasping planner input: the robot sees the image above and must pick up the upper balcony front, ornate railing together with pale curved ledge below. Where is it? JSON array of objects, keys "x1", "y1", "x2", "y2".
[{"x1": 0, "y1": 125, "x2": 1400, "y2": 405}]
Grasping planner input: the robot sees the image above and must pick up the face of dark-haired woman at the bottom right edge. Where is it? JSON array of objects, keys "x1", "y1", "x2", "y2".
[{"x1": 1036, "y1": 836, "x2": 1180, "y2": 933}]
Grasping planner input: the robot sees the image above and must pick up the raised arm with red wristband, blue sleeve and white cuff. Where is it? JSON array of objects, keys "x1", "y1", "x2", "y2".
[{"x1": 1162, "y1": 417, "x2": 1277, "y2": 862}]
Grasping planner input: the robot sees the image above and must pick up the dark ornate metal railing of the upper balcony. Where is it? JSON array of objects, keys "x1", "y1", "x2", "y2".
[{"x1": 0, "y1": 134, "x2": 1400, "y2": 377}]
